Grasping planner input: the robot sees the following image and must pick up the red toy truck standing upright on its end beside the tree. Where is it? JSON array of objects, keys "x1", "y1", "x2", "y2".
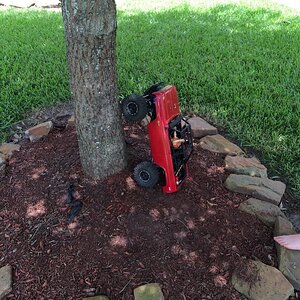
[{"x1": 122, "y1": 83, "x2": 193, "y2": 193}]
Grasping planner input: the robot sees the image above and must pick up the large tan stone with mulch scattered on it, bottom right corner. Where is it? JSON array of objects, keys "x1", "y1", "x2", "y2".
[{"x1": 231, "y1": 260, "x2": 294, "y2": 300}]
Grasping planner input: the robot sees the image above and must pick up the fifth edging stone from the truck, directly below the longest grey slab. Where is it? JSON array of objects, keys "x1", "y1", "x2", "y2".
[{"x1": 239, "y1": 198, "x2": 285, "y2": 227}]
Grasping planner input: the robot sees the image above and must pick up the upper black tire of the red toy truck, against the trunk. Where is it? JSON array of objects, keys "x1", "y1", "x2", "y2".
[{"x1": 122, "y1": 94, "x2": 148, "y2": 122}]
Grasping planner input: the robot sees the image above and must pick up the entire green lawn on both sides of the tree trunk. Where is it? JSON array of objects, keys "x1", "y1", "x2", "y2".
[{"x1": 0, "y1": 0, "x2": 300, "y2": 197}]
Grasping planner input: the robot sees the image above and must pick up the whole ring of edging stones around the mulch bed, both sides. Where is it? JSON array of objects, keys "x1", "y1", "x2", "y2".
[{"x1": 0, "y1": 113, "x2": 300, "y2": 300}]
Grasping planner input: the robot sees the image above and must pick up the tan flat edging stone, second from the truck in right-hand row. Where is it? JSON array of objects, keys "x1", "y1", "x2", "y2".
[{"x1": 200, "y1": 134, "x2": 244, "y2": 155}]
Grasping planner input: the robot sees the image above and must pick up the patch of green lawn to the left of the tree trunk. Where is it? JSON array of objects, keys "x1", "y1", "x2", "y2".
[{"x1": 0, "y1": 10, "x2": 70, "y2": 131}]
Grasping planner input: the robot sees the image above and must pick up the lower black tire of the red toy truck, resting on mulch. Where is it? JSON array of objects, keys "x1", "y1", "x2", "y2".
[{"x1": 133, "y1": 161, "x2": 160, "y2": 188}]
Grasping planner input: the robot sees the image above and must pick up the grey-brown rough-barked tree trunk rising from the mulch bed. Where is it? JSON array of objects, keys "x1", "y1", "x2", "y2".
[{"x1": 62, "y1": 0, "x2": 126, "y2": 178}]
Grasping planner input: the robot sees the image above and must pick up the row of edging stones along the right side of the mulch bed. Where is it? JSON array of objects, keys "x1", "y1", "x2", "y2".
[{"x1": 190, "y1": 117, "x2": 300, "y2": 300}]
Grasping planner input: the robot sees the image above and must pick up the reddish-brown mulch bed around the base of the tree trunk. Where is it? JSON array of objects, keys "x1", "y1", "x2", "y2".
[{"x1": 0, "y1": 125, "x2": 276, "y2": 300}]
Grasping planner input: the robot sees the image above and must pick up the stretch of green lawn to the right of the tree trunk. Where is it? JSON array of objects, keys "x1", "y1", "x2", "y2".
[{"x1": 118, "y1": 5, "x2": 300, "y2": 196}]
